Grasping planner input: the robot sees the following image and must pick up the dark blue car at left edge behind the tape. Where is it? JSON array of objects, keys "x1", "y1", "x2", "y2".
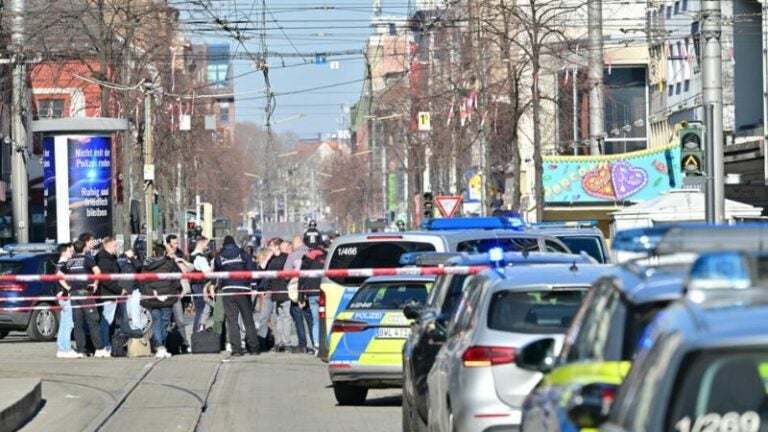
[{"x1": 0, "y1": 252, "x2": 59, "y2": 341}]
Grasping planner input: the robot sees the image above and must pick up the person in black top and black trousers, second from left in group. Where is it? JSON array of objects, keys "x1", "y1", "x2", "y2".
[{"x1": 59, "y1": 240, "x2": 109, "y2": 357}]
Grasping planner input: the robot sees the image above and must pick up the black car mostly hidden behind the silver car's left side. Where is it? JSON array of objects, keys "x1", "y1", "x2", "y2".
[{"x1": 402, "y1": 252, "x2": 594, "y2": 431}]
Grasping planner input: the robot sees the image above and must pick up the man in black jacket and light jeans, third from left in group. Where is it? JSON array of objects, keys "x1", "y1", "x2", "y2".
[{"x1": 96, "y1": 236, "x2": 125, "y2": 351}]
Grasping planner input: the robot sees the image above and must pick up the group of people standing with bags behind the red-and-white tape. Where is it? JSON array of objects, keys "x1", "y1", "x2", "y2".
[{"x1": 56, "y1": 221, "x2": 326, "y2": 358}]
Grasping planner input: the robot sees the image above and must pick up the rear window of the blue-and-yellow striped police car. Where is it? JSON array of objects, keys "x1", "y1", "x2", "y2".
[{"x1": 347, "y1": 282, "x2": 431, "y2": 310}]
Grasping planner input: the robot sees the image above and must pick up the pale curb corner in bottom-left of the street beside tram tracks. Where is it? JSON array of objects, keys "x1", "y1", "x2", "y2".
[{"x1": 0, "y1": 378, "x2": 42, "y2": 431}]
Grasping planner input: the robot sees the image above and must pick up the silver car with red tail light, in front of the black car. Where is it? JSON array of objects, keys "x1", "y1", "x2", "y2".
[{"x1": 427, "y1": 263, "x2": 611, "y2": 432}]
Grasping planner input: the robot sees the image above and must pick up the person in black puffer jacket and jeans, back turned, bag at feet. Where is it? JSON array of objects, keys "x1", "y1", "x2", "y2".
[{"x1": 141, "y1": 244, "x2": 181, "y2": 358}]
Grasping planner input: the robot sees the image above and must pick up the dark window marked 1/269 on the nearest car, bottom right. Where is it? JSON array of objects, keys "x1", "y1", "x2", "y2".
[{"x1": 666, "y1": 347, "x2": 768, "y2": 431}]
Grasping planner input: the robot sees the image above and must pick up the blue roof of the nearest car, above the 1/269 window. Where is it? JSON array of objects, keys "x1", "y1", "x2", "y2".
[{"x1": 657, "y1": 288, "x2": 768, "y2": 348}]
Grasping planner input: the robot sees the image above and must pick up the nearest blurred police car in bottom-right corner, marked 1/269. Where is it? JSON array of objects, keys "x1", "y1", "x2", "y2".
[{"x1": 596, "y1": 252, "x2": 768, "y2": 432}]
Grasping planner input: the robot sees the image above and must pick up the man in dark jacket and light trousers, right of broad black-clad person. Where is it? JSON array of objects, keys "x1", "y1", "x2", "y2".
[{"x1": 263, "y1": 238, "x2": 293, "y2": 352}]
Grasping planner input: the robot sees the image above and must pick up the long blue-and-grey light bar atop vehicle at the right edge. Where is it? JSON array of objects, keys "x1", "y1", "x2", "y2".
[{"x1": 611, "y1": 223, "x2": 768, "y2": 255}]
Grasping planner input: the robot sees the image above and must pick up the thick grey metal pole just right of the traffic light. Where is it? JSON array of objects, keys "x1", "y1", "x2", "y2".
[{"x1": 701, "y1": 0, "x2": 725, "y2": 223}]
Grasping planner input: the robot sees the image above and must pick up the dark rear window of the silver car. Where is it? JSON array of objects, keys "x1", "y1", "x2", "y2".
[{"x1": 488, "y1": 288, "x2": 587, "y2": 334}]
